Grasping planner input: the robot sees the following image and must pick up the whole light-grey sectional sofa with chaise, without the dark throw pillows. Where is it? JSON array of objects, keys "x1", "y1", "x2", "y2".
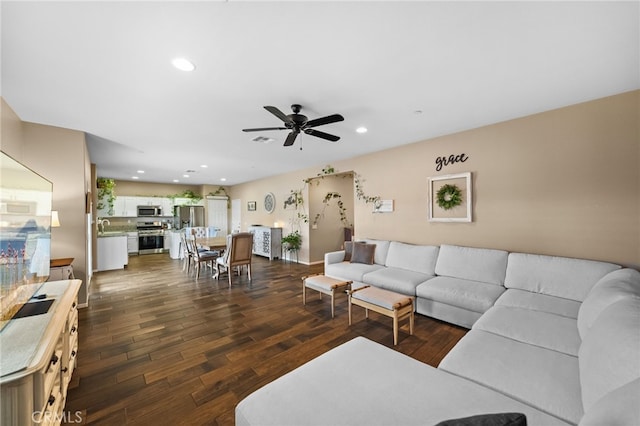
[{"x1": 236, "y1": 241, "x2": 640, "y2": 426}]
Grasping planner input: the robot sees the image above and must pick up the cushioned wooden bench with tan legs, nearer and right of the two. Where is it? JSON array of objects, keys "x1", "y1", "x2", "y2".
[{"x1": 349, "y1": 286, "x2": 414, "y2": 346}]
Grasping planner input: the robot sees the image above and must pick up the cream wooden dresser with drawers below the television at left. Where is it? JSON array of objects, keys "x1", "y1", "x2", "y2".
[{"x1": 0, "y1": 280, "x2": 82, "y2": 426}]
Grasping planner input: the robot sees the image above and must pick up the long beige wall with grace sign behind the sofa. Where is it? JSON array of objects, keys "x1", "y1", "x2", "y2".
[{"x1": 231, "y1": 91, "x2": 640, "y2": 266}]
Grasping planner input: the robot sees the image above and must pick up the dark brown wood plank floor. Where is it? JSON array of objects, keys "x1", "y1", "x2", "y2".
[{"x1": 65, "y1": 254, "x2": 466, "y2": 425}]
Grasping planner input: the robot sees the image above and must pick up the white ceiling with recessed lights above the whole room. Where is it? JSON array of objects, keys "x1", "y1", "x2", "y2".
[{"x1": 1, "y1": 0, "x2": 640, "y2": 185}]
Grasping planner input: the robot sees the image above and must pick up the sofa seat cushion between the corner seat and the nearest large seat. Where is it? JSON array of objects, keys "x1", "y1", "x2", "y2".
[{"x1": 473, "y1": 306, "x2": 581, "y2": 356}]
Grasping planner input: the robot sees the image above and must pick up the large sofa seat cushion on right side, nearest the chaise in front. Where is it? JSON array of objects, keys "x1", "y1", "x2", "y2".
[{"x1": 438, "y1": 330, "x2": 583, "y2": 424}]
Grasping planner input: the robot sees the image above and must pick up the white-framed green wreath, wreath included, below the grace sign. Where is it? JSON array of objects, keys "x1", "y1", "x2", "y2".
[{"x1": 429, "y1": 172, "x2": 472, "y2": 222}]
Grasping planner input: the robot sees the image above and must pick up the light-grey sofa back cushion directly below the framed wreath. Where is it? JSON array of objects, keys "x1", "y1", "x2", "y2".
[{"x1": 435, "y1": 245, "x2": 508, "y2": 285}]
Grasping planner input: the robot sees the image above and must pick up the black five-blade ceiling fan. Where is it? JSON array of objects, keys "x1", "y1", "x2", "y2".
[{"x1": 242, "y1": 104, "x2": 344, "y2": 146}]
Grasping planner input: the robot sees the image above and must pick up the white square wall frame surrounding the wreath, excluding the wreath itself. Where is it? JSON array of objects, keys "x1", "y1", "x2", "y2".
[{"x1": 428, "y1": 172, "x2": 473, "y2": 222}]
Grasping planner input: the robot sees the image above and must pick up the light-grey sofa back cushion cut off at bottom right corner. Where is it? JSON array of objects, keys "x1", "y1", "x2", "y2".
[{"x1": 579, "y1": 379, "x2": 640, "y2": 426}]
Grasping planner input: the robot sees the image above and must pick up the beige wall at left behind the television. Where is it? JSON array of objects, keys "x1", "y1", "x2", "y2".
[{"x1": 2, "y1": 100, "x2": 91, "y2": 304}]
